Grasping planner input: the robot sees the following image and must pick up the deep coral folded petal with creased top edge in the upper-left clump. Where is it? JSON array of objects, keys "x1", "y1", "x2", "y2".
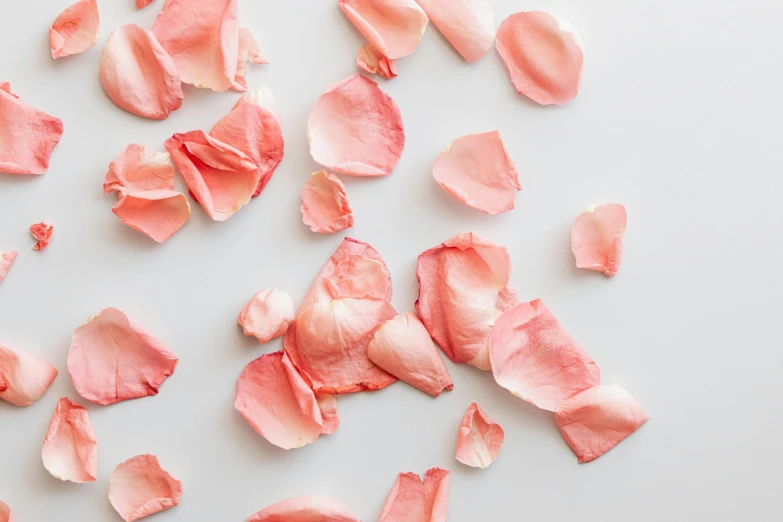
[{"x1": 164, "y1": 131, "x2": 261, "y2": 221}]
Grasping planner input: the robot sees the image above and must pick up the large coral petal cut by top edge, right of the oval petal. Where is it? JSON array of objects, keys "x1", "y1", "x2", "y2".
[{"x1": 152, "y1": 0, "x2": 239, "y2": 91}]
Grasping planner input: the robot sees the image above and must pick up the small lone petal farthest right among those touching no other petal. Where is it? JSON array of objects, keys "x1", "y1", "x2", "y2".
[{"x1": 571, "y1": 203, "x2": 628, "y2": 277}]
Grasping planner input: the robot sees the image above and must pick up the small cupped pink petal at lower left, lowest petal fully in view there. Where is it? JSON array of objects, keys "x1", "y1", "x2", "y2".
[{"x1": 109, "y1": 455, "x2": 182, "y2": 522}]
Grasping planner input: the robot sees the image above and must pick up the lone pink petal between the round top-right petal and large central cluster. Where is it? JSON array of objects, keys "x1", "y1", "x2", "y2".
[{"x1": 432, "y1": 131, "x2": 522, "y2": 215}]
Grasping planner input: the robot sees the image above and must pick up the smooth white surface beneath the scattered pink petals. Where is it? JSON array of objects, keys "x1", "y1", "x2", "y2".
[{"x1": 0, "y1": 0, "x2": 783, "y2": 522}]
